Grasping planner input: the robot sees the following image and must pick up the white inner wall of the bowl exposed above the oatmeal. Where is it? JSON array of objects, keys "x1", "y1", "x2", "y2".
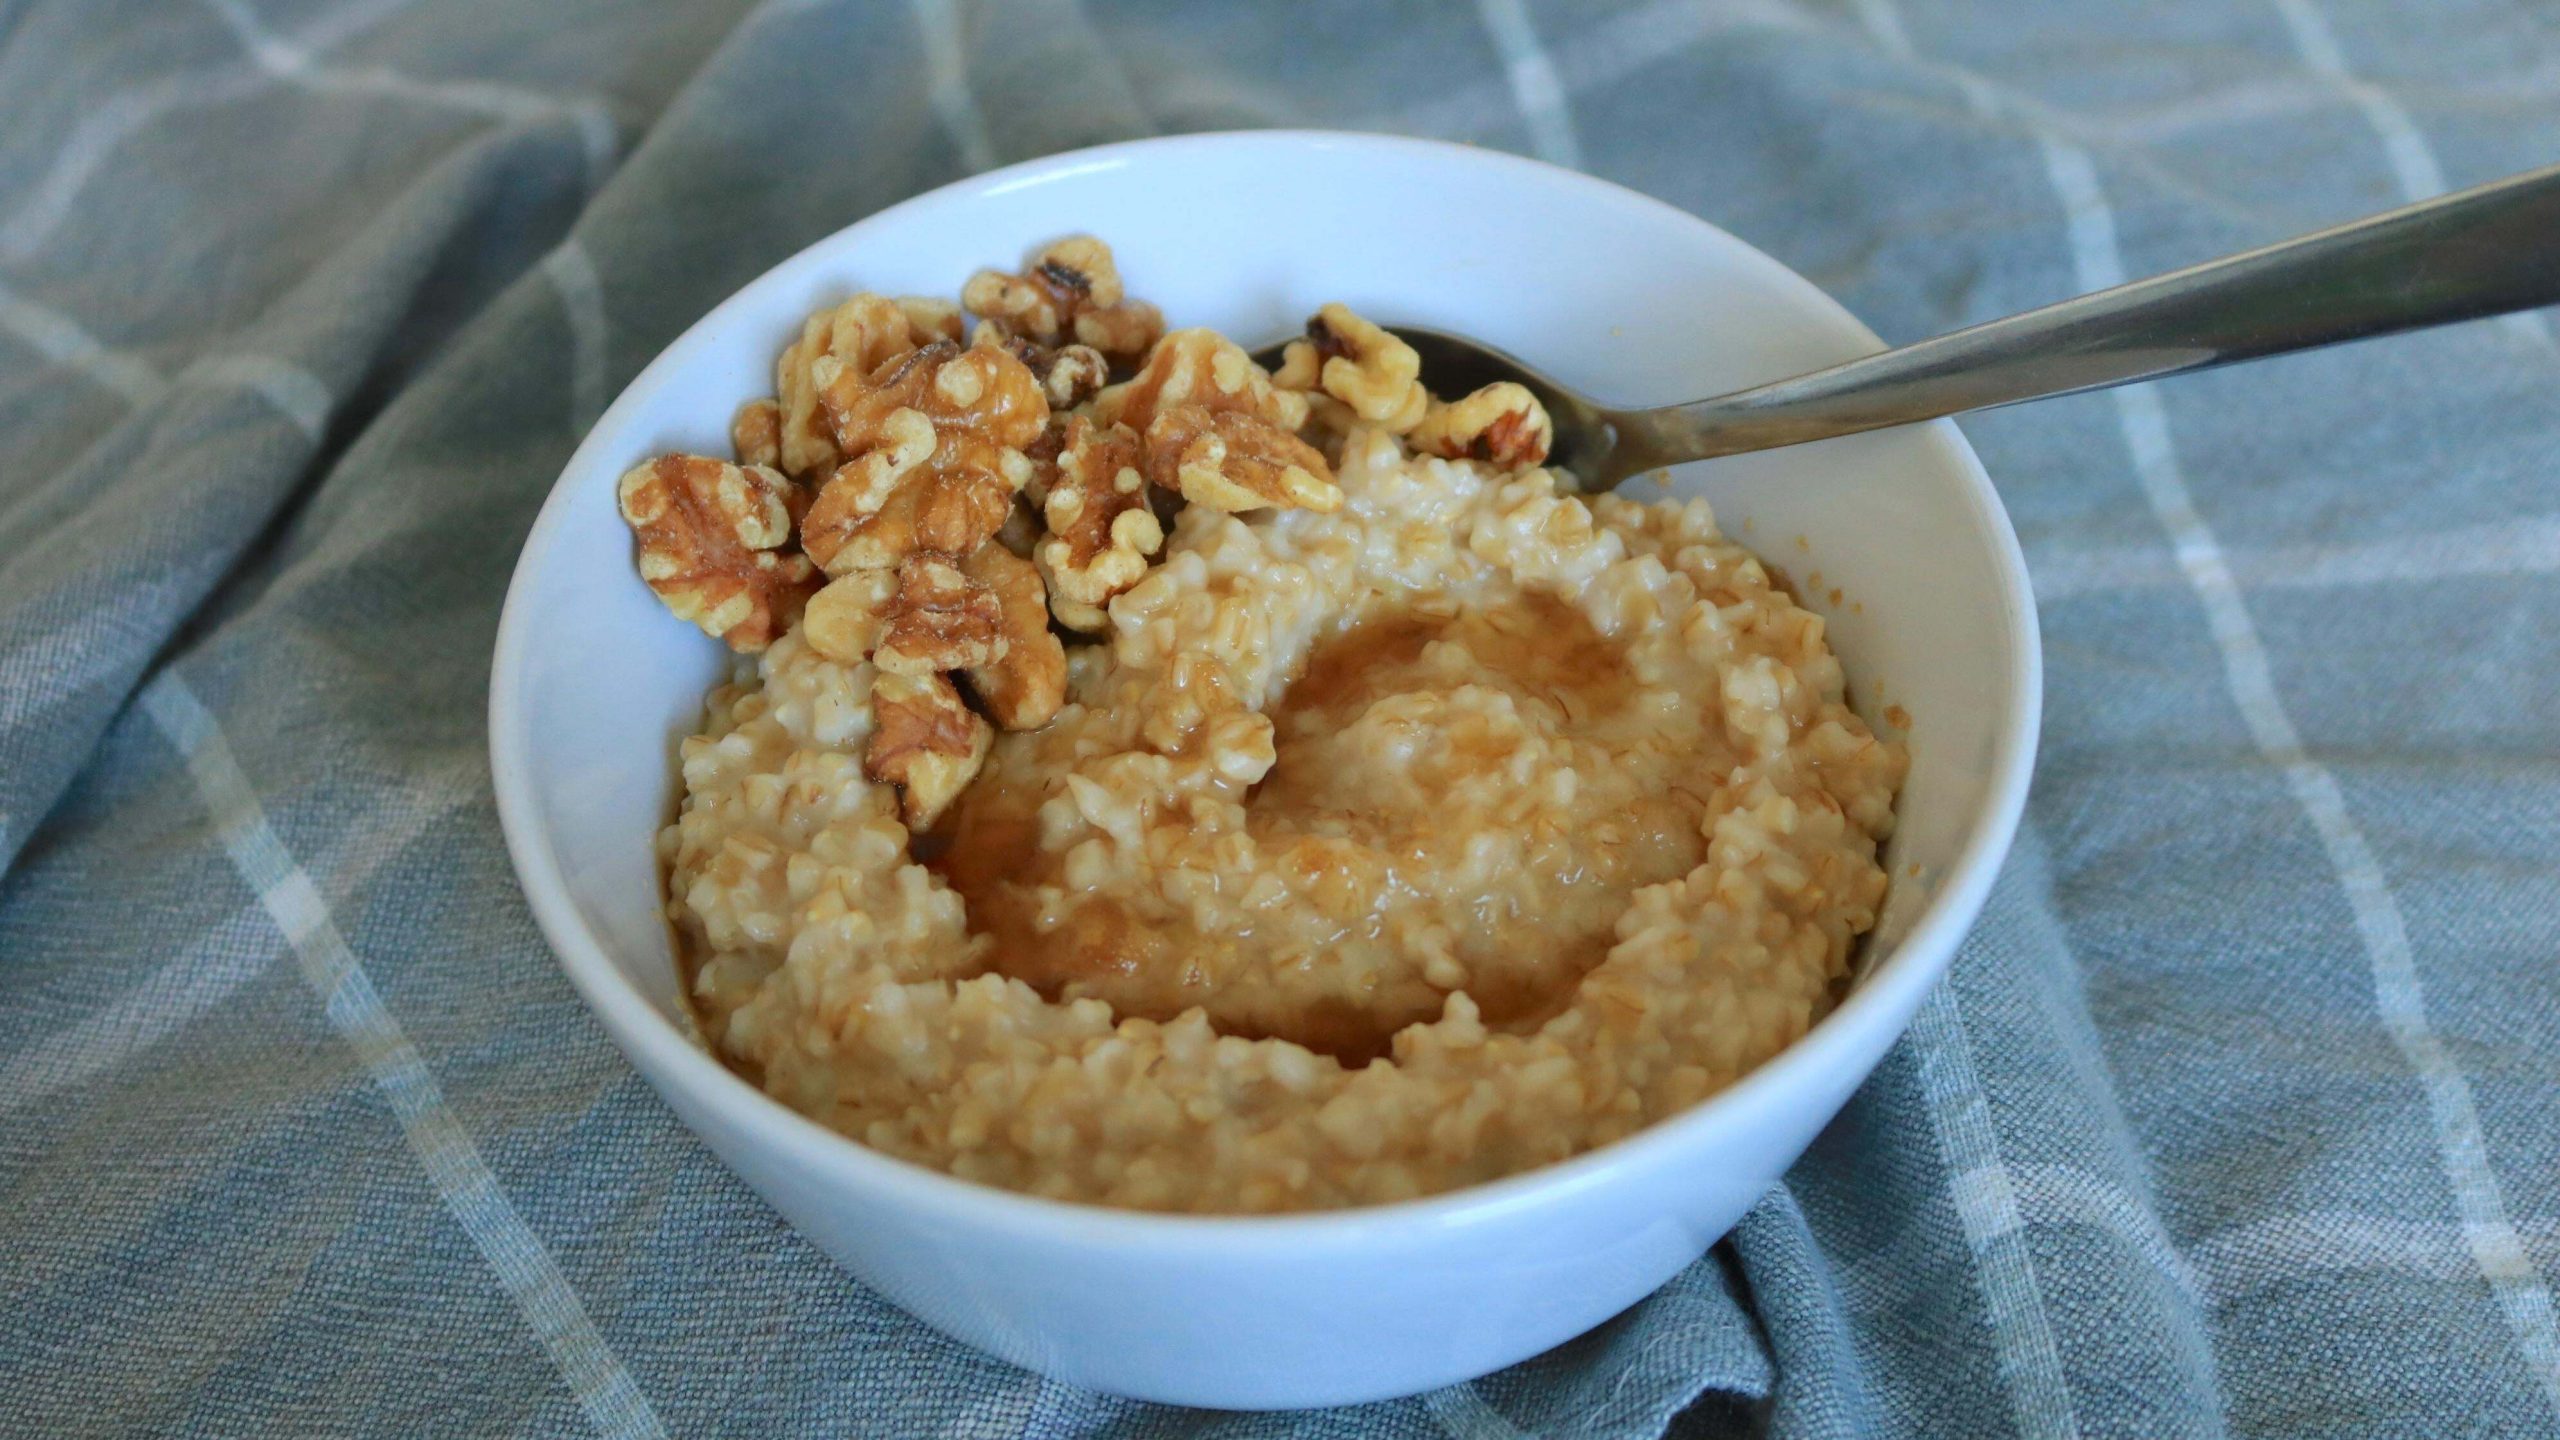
[{"x1": 499, "y1": 138, "x2": 2022, "y2": 1017}]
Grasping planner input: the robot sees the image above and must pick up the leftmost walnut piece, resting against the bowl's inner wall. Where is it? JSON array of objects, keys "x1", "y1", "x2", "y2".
[{"x1": 614, "y1": 456, "x2": 817, "y2": 651}]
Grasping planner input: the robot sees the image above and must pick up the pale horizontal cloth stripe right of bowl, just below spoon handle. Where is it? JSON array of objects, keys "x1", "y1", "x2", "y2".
[{"x1": 2030, "y1": 515, "x2": 2560, "y2": 600}]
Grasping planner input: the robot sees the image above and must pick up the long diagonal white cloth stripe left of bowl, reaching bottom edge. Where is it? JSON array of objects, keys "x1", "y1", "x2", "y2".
[{"x1": 141, "y1": 669, "x2": 666, "y2": 1440}]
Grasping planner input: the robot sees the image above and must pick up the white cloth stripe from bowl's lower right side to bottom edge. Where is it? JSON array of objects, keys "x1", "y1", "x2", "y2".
[{"x1": 1910, "y1": 981, "x2": 2079, "y2": 1437}]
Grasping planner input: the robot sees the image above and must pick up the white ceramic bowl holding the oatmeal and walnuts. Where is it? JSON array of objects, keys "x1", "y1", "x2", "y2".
[{"x1": 489, "y1": 133, "x2": 2040, "y2": 1407}]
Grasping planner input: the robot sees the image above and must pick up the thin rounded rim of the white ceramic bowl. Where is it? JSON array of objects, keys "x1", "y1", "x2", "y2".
[{"x1": 489, "y1": 128, "x2": 2043, "y2": 1256}]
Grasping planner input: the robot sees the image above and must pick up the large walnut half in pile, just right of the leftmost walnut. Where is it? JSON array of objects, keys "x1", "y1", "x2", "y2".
[{"x1": 801, "y1": 341, "x2": 1050, "y2": 574}]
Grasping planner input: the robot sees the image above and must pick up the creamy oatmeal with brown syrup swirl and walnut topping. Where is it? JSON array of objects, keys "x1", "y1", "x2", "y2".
[{"x1": 625, "y1": 238, "x2": 1905, "y2": 1212}]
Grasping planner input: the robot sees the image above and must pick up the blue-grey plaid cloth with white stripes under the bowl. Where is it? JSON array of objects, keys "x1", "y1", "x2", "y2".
[{"x1": 0, "y1": 0, "x2": 2560, "y2": 1440}]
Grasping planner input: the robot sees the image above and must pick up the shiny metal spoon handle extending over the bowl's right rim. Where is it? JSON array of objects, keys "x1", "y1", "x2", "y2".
[{"x1": 1618, "y1": 167, "x2": 2560, "y2": 464}]
